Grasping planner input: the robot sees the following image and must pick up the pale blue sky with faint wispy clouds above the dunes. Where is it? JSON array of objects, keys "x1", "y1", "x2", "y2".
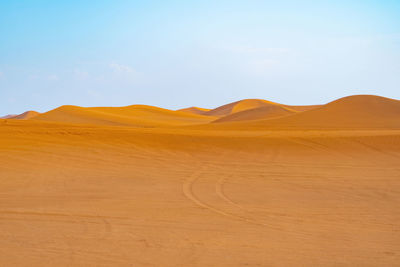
[{"x1": 0, "y1": 0, "x2": 400, "y2": 115}]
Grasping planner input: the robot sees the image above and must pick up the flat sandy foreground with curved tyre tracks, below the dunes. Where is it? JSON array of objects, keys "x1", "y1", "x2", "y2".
[{"x1": 0, "y1": 120, "x2": 400, "y2": 267}]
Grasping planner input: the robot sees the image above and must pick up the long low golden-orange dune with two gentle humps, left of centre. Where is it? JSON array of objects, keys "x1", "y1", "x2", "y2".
[{"x1": 33, "y1": 105, "x2": 214, "y2": 127}]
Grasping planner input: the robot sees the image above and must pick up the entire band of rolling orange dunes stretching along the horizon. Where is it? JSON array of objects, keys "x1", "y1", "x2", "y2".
[{"x1": 16, "y1": 95, "x2": 400, "y2": 130}]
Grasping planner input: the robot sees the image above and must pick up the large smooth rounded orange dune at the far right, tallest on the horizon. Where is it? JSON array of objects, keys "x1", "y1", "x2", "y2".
[{"x1": 203, "y1": 95, "x2": 400, "y2": 130}]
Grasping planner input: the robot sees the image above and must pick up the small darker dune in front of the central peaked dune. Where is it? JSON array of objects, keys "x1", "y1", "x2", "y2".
[{"x1": 214, "y1": 105, "x2": 296, "y2": 122}]
